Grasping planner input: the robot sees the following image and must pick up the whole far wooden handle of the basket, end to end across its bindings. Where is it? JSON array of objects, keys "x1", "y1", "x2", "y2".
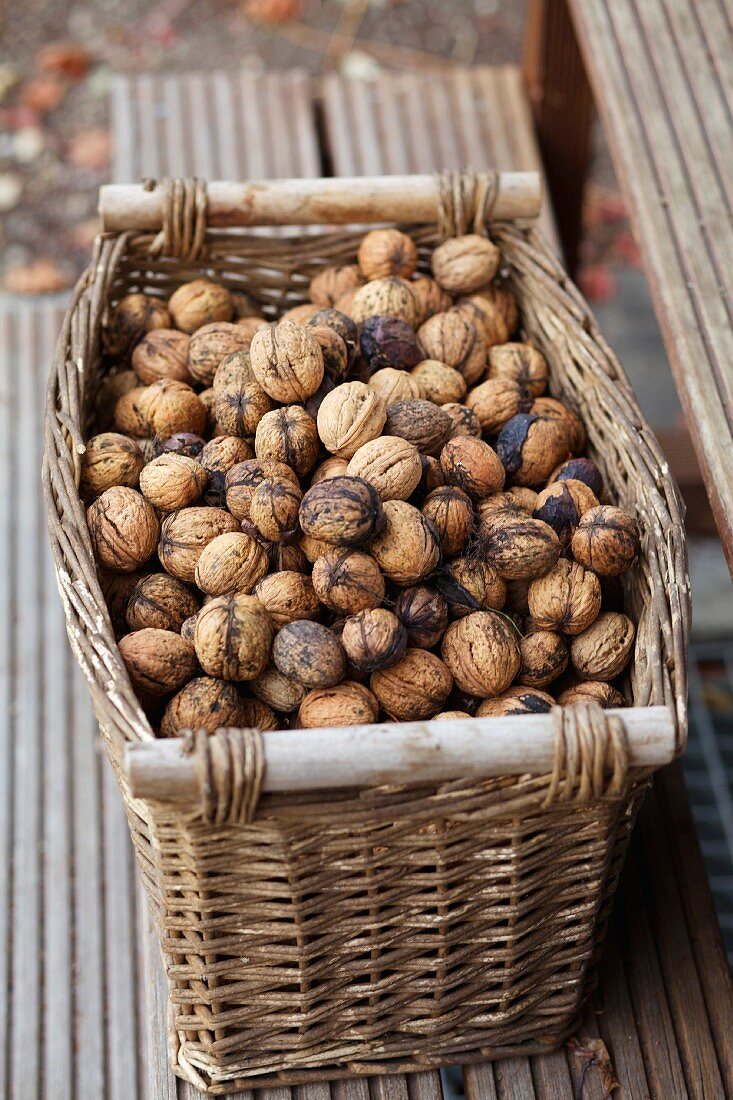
[{"x1": 99, "y1": 172, "x2": 541, "y2": 233}]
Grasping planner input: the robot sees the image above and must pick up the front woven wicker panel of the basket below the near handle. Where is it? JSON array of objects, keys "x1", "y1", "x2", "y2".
[{"x1": 131, "y1": 776, "x2": 646, "y2": 1087}]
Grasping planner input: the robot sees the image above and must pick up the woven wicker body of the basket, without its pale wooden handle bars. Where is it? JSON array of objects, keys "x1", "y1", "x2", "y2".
[{"x1": 43, "y1": 173, "x2": 689, "y2": 1093}]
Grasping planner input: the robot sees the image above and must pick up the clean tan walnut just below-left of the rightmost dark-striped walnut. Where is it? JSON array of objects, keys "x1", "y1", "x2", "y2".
[{"x1": 527, "y1": 558, "x2": 601, "y2": 634}]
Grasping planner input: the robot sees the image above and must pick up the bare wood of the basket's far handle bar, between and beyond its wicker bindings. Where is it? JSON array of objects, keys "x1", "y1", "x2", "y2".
[{"x1": 99, "y1": 172, "x2": 541, "y2": 232}]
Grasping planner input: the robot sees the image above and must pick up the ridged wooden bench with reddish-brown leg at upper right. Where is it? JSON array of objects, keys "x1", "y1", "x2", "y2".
[{"x1": 526, "y1": 0, "x2": 733, "y2": 572}]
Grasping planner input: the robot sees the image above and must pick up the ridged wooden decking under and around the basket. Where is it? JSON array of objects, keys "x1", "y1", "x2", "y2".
[{"x1": 0, "y1": 69, "x2": 733, "y2": 1100}]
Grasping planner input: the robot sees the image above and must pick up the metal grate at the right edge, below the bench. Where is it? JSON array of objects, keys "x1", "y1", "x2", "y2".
[{"x1": 682, "y1": 640, "x2": 733, "y2": 965}]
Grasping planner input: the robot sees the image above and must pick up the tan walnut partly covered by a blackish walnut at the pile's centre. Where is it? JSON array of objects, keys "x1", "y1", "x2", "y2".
[{"x1": 370, "y1": 501, "x2": 440, "y2": 585}]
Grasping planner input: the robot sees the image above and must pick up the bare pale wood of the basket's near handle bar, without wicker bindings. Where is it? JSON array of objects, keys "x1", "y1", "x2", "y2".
[{"x1": 124, "y1": 706, "x2": 676, "y2": 804}]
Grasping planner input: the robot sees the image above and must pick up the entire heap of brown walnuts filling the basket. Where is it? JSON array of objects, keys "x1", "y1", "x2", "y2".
[{"x1": 80, "y1": 229, "x2": 639, "y2": 736}]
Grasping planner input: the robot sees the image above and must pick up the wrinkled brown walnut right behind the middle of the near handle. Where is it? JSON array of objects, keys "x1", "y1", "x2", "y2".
[{"x1": 370, "y1": 649, "x2": 453, "y2": 722}]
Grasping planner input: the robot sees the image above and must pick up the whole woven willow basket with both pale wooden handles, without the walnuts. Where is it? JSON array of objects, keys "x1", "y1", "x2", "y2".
[{"x1": 43, "y1": 171, "x2": 689, "y2": 1093}]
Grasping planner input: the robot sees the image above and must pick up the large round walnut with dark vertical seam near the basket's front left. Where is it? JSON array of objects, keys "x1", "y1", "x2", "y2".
[{"x1": 194, "y1": 592, "x2": 274, "y2": 680}]
